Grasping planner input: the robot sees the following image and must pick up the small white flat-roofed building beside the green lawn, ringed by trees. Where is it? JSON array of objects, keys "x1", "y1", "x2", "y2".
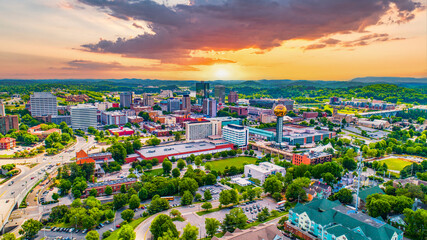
[{"x1": 244, "y1": 162, "x2": 286, "y2": 183}]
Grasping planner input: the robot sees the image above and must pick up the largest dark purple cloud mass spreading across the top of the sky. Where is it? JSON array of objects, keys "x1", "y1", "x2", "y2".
[{"x1": 80, "y1": 0, "x2": 422, "y2": 64}]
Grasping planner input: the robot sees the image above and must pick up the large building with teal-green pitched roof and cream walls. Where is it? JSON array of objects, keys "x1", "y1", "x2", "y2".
[{"x1": 286, "y1": 199, "x2": 403, "y2": 240}]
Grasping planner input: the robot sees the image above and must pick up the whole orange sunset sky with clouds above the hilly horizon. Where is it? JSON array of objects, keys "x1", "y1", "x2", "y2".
[{"x1": 0, "y1": 0, "x2": 427, "y2": 80}]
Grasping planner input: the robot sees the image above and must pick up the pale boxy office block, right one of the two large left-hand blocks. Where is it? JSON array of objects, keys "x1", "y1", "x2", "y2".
[{"x1": 70, "y1": 104, "x2": 98, "y2": 130}]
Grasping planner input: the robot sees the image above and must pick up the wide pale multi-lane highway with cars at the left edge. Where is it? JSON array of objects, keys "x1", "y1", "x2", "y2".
[{"x1": 0, "y1": 137, "x2": 95, "y2": 230}]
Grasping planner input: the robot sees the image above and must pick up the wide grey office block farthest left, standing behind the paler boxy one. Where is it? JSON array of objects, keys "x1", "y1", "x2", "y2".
[{"x1": 30, "y1": 92, "x2": 58, "y2": 117}]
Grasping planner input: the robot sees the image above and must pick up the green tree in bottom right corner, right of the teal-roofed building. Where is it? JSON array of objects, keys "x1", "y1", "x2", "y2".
[{"x1": 403, "y1": 209, "x2": 427, "y2": 240}]
